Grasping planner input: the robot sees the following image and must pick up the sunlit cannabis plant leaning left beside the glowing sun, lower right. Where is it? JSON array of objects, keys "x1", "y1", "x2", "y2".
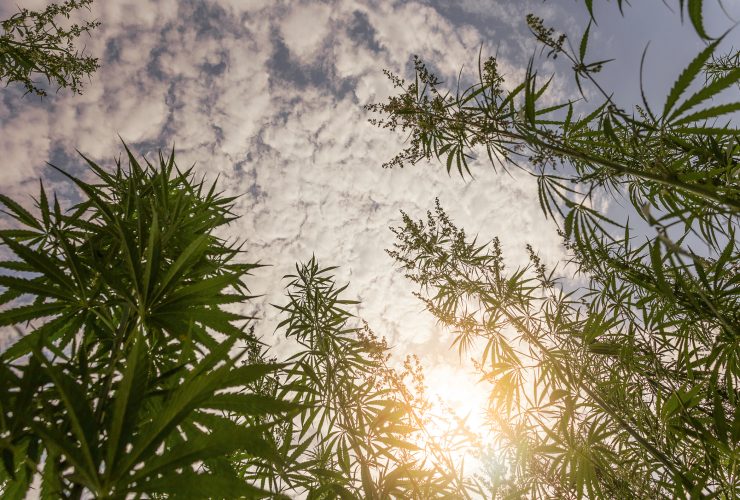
[{"x1": 390, "y1": 198, "x2": 740, "y2": 498}]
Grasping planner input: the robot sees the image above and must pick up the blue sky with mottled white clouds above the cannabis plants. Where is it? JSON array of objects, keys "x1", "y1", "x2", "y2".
[{"x1": 0, "y1": 0, "x2": 740, "y2": 442}]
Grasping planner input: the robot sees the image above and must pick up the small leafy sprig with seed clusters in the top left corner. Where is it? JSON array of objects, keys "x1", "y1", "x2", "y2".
[{"x1": 0, "y1": 0, "x2": 100, "y2": 96}]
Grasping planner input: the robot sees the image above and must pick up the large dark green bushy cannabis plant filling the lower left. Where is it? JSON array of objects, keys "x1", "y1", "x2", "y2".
[{"x1": 0, "y1": 150, "x2": 295, "y2": 498}]
